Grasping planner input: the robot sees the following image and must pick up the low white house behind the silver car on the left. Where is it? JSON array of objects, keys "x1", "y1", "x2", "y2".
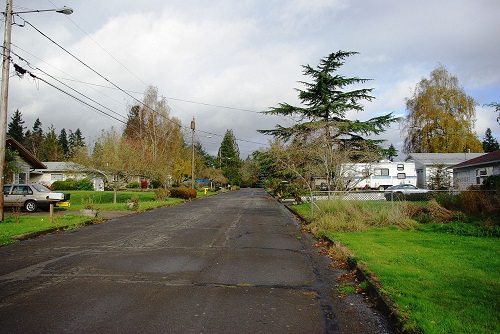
[{"x1": 30, "y1": 161, "x2": 104, "y2": 190}]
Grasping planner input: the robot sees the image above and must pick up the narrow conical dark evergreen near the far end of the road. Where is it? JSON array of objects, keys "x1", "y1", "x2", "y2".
[{"x1": 218, "y1": 130, "x2": 242, "y2": 186}]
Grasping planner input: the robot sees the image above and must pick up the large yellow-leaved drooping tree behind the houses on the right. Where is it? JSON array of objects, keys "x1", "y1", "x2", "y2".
[{"x1": 403, "y1": 65, "x2": 482, "y2": 153}]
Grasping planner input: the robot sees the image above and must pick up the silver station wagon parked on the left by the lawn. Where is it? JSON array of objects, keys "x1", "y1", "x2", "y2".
[{"x1": 3, "y1": 183, "x2": 71, "y2": 212}]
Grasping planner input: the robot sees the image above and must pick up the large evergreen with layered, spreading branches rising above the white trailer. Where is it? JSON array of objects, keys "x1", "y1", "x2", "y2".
[{"x1": 259, "y1": 51, "x2": 397, "y2": 160}]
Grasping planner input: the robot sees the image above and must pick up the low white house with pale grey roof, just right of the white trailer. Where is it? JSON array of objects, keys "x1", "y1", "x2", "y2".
[{"x1": 405, "y1": 153, "x2": 484, "y2": 188}]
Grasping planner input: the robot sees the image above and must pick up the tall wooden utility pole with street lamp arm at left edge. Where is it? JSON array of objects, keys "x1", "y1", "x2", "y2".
[{"x1": 0, "y1": 0, "x2": 73, "y2": 221}]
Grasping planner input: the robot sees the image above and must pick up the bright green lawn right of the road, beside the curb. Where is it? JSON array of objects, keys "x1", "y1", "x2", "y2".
[{"x1": 293, "y1": 204, "x2": 500, "y2": 333}]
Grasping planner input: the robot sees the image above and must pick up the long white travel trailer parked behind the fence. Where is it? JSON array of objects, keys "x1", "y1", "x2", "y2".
[{"x1": 340, "y1": 160, "x2": 417, "y2": 190}]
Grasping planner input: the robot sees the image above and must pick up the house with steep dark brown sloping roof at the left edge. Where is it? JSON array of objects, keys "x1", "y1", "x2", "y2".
[{"x1": 6, "y1": 137, "x2": 47, "y2": 183}]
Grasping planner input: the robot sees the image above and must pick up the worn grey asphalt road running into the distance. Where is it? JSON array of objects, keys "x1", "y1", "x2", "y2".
[{"x1": 0, "y1": 189, "x2": 388, "y2": 334}]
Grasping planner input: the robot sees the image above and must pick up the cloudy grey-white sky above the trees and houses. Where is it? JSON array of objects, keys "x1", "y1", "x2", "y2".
[{"x1": 2, "y1": 0, "x2": 500, "y2": 158}]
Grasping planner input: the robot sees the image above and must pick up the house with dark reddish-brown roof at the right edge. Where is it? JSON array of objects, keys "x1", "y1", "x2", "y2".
[{"x1": 452, "y1": 150, "x2": 500, "y2": 190}]
